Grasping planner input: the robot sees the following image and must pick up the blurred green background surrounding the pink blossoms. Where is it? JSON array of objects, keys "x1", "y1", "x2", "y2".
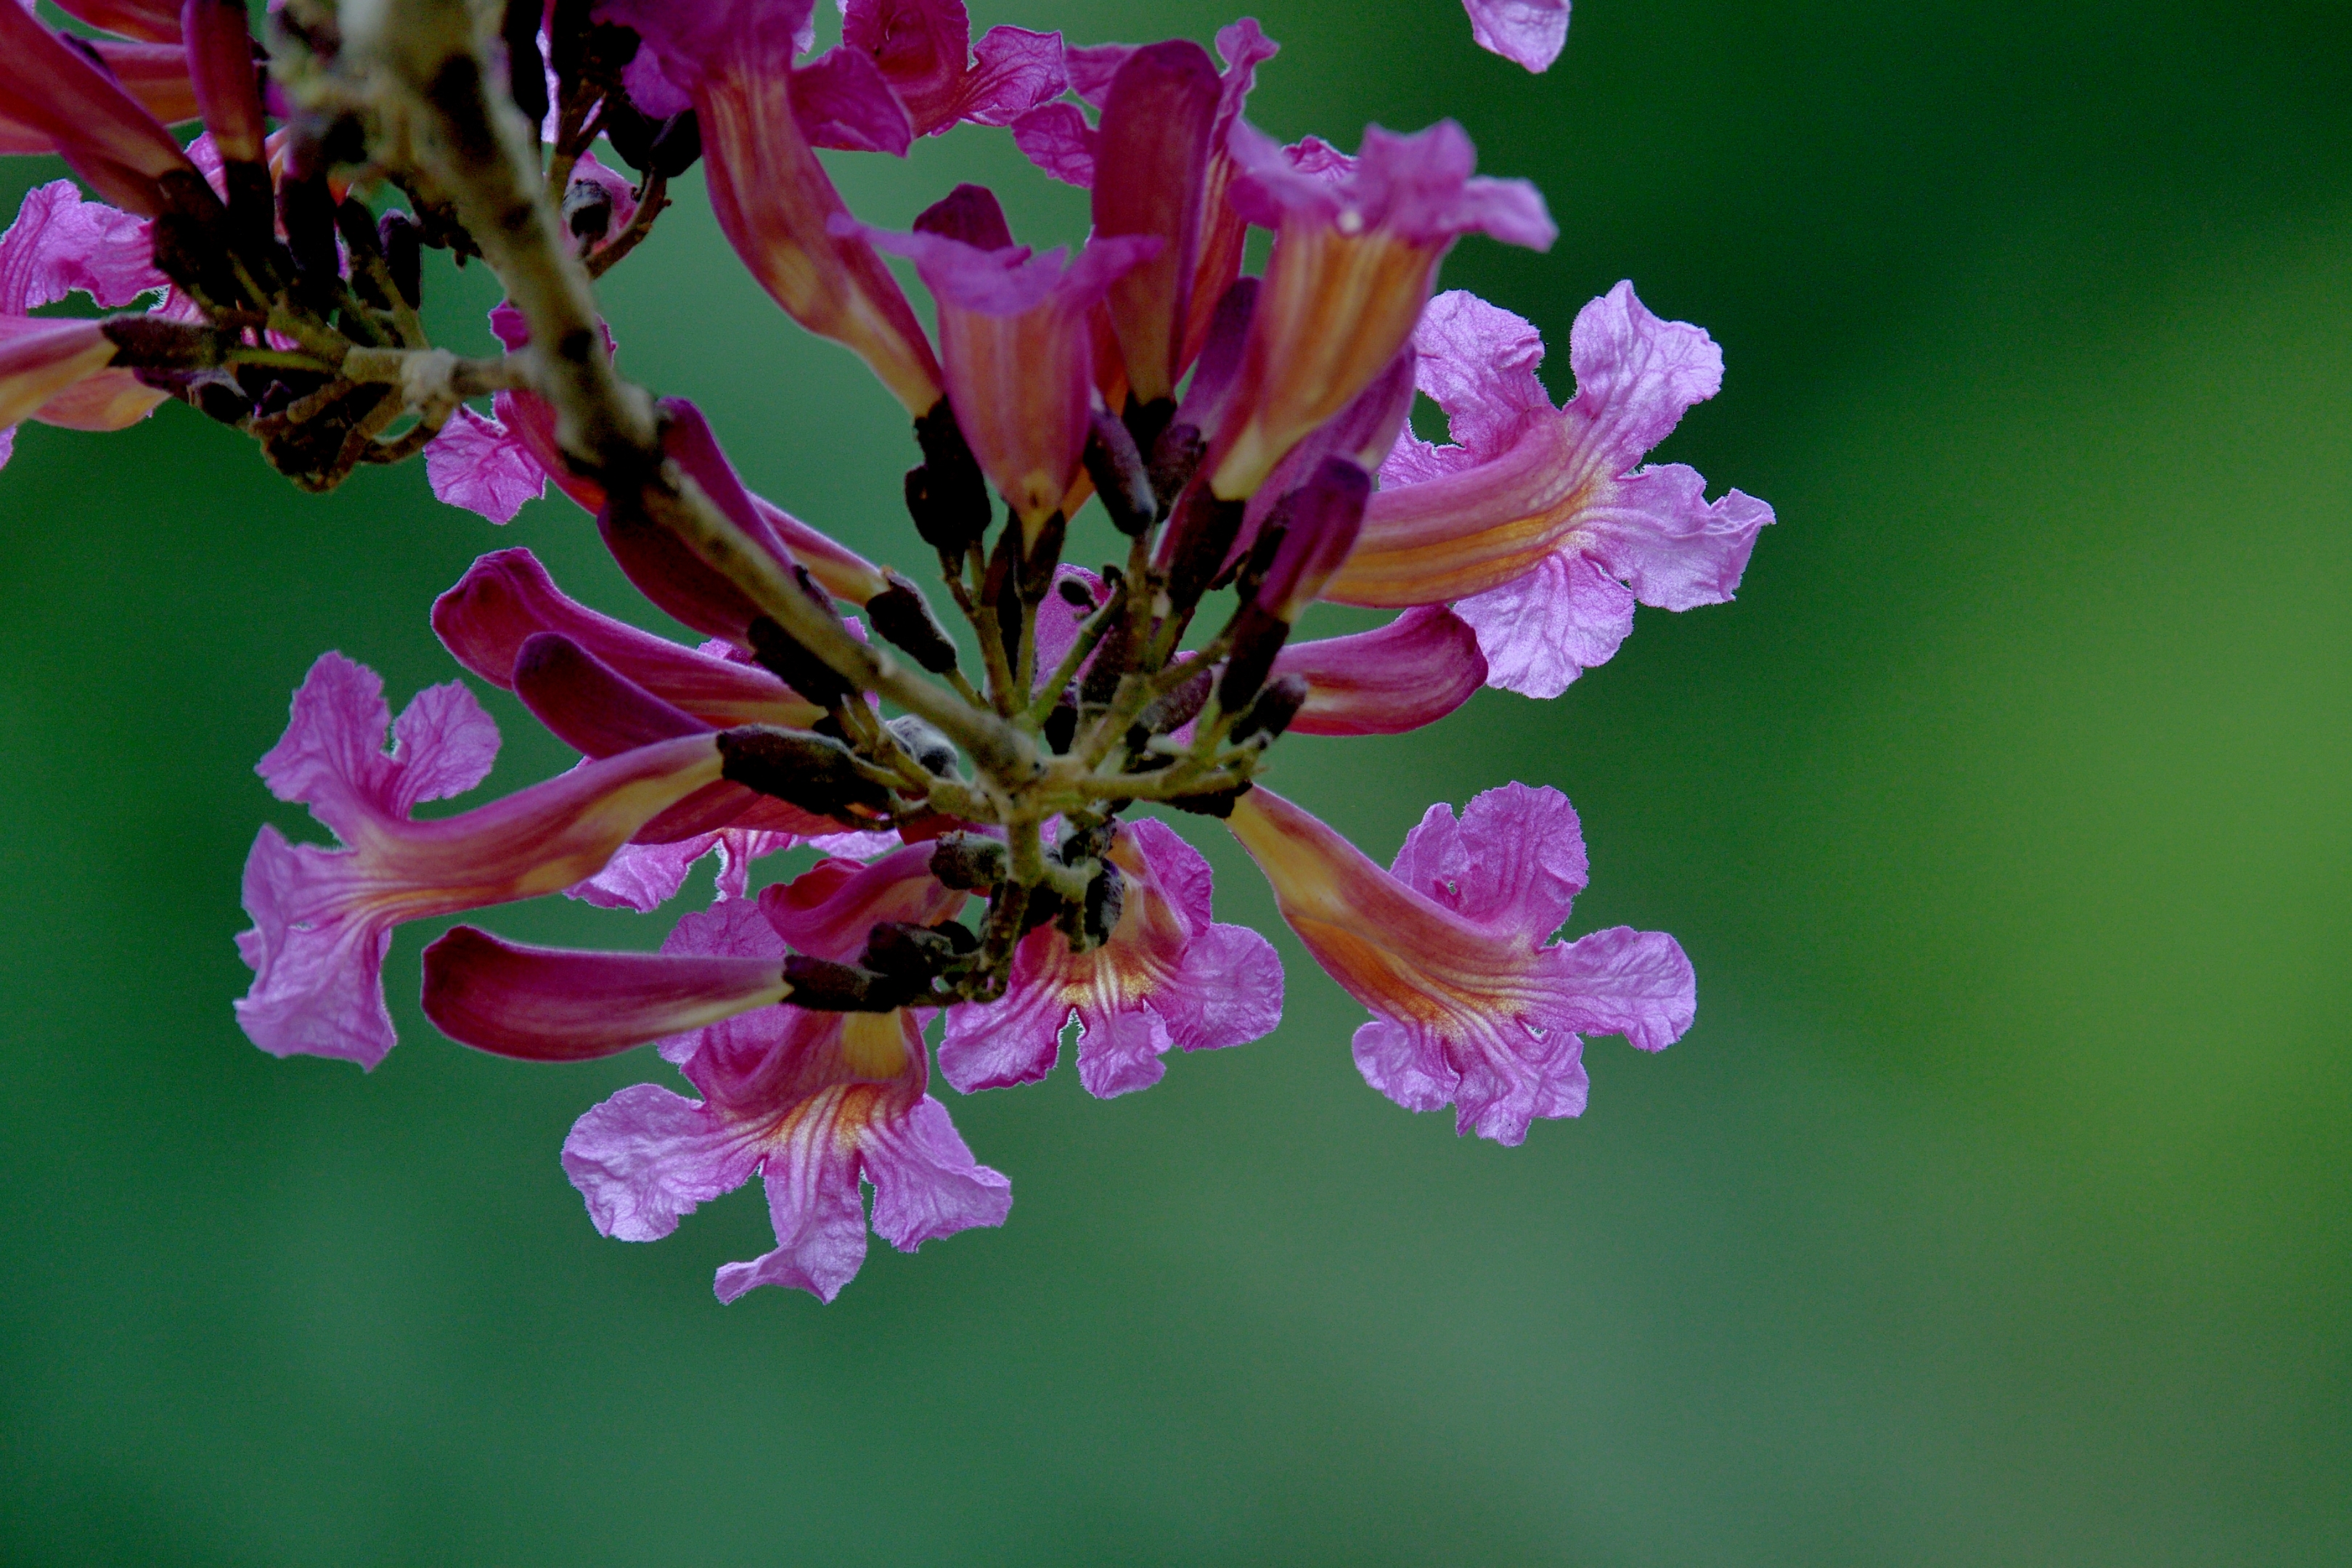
[{"x1": 0, "y1": 0, "x2": 2352, "y2": 1568}]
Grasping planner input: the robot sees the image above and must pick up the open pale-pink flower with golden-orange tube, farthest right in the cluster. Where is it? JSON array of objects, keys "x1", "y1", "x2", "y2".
[{"x1": 1324, "y1": 282, "x2": 1771, "y2": 696}]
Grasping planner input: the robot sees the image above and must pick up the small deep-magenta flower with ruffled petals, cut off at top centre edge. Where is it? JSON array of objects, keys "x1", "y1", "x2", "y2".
[{"x1": 842, "y1": 0, "x2": 1066, "y2": 136}]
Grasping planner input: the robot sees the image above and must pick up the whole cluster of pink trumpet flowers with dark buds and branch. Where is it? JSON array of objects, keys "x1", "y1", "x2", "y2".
[{"x1": 0, "y1": 0, "x2": 1771, "y2": 1300}]
